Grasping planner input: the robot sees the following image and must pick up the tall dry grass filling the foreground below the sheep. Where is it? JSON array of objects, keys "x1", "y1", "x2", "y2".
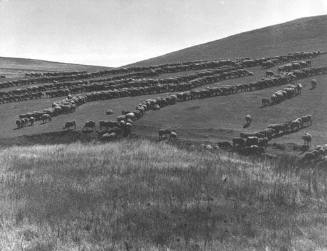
[{"x1": 0, "y1": 140, "x2": 327, "y2": 250}]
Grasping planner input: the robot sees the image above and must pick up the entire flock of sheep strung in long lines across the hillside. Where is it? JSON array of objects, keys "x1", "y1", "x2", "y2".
[{"x1": 0, "y1": 51, "x2": 327, "y2": 159}]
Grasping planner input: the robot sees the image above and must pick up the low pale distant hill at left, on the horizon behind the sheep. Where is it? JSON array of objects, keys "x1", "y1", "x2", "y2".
[{"x1": 0, "y1": 57, "x2": 109, "y2": 74}]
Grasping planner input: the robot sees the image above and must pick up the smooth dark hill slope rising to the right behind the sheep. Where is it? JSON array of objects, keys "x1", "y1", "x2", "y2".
[{"x1": 133, "y1": 15, "x2": 327, "y2": 66}]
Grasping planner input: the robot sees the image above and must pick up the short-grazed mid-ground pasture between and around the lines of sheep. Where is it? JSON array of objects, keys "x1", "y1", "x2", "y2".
[{"x1": 0, "y1": 54, "x2": 327, "y2": 158}]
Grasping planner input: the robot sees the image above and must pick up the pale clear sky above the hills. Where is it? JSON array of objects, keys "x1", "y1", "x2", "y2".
[{"x1": 0, "y1": 0, "x2": 327, "y2": 66}]
